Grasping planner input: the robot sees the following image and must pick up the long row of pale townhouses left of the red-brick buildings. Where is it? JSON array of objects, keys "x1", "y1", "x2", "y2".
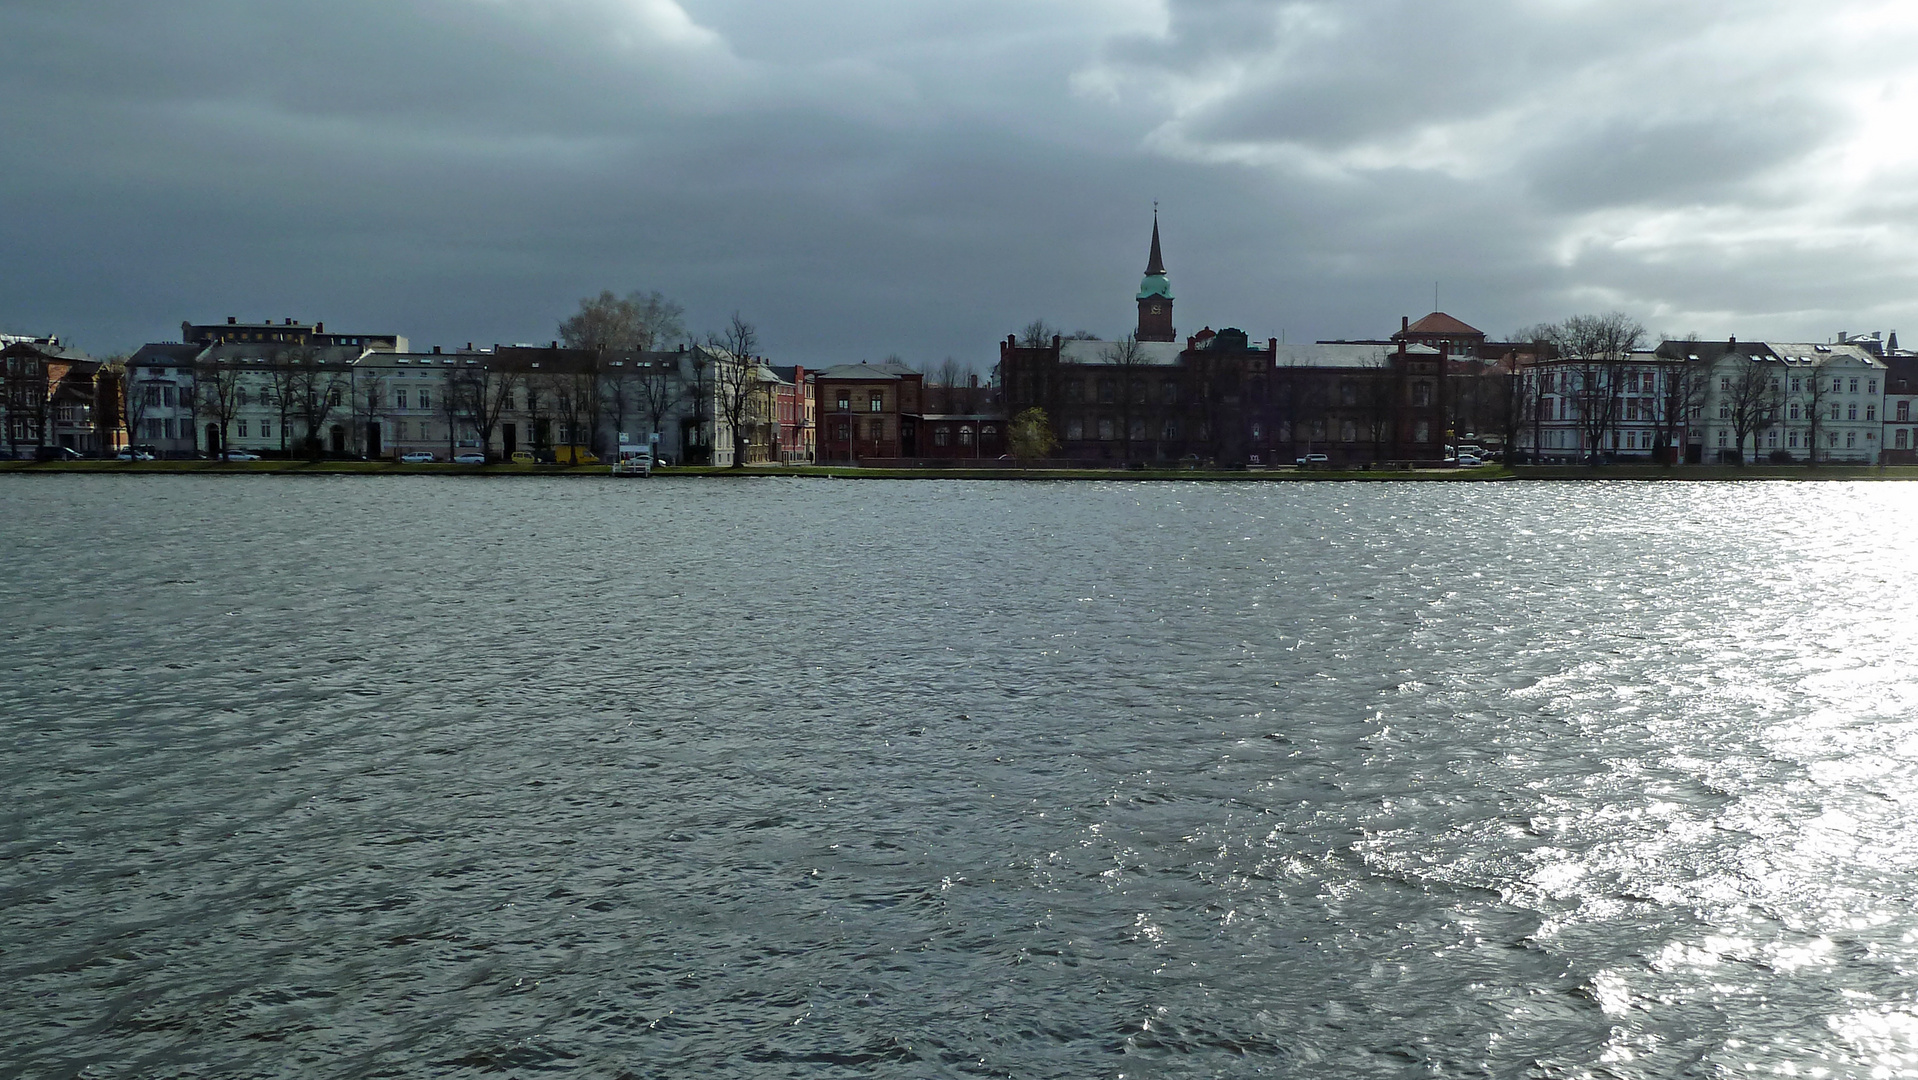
[{"x1": 112, "y1": 318, "x2": 813, "y2": 464}]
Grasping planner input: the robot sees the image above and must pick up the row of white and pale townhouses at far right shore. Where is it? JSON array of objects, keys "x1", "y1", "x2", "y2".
[{"x1": 1517, "y1": 336, "x2": 1918, "y2": 464}]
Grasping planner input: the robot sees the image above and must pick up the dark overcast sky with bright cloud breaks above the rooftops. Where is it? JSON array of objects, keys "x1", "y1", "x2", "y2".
[{"x1": 0, "y1": 0, "x2": 1918, "y2": 368}]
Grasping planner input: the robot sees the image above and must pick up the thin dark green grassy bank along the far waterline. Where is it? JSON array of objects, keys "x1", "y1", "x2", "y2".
[{"x1": 11, "y1": 460, "x2": 1918, "y2": 483}]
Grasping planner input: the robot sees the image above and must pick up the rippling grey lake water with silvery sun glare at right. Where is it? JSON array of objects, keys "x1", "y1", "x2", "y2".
[{"x1": 0, "y1": 476, "x2": 1918, "y2": 1078}]
